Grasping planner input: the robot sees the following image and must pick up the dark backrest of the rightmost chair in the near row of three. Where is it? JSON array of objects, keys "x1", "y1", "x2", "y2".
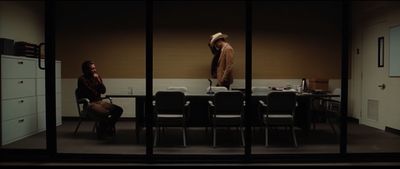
[{"x1": 266, "y1": 91, "x2": 296, "y2": 115}]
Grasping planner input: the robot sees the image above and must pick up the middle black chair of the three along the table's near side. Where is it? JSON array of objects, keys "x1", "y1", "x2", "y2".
[{"x1": 209, "y1": 91, "x2": 245, "y2": 148}]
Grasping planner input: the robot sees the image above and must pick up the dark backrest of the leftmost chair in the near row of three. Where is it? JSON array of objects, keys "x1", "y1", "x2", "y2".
[{"x1": 155, "y1": 91, "x2": 186, "y2": 114}]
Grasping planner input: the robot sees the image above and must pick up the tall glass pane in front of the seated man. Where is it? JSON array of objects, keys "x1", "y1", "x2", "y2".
[{"x1": 56, "y1": 1, "x2": 146, "y2": 154}]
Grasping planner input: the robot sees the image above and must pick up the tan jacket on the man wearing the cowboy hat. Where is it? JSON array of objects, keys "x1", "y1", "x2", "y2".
[{"x1": 217, "y1": 43, "x2": 234, "y2": 86}]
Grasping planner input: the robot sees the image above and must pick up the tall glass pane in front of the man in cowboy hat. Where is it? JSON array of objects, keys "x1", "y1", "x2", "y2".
[{"x1": 153, "y1": 1, "x2": 245, "y2": 155}]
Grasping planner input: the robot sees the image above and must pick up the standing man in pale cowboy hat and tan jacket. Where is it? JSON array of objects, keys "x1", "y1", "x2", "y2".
[{"x1": 209, "y1": 32, "x2": 234, "y2": 89}]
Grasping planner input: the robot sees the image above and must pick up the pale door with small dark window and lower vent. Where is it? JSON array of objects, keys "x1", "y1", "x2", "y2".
[{"x1": 360, "y1": 22, "x2": 388, "y2": 129}]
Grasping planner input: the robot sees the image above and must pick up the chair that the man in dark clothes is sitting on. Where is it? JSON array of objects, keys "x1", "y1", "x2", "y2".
[{"x1": 74, "y1": 89, "x2": 115, "y2": 135}]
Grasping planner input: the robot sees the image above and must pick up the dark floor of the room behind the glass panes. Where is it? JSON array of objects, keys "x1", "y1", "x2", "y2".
[{"x1": 2, "y1": 120, "x2": 400, "y2": 154}]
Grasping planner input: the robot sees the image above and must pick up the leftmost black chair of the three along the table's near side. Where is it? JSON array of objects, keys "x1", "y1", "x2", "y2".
[{"x1": 154, "y1": 91, "x2": 190, "y2": 147}]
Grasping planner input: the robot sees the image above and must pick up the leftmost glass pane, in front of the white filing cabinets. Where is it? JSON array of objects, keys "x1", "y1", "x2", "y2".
[{"x1": 0, "y1": 1, "x2": 46, "y2": 149}]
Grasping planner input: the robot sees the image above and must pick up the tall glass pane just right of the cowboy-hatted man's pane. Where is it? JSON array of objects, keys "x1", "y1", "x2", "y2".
[{"x1": 252, "y1": 1, "x2": 342, "y2": 154}]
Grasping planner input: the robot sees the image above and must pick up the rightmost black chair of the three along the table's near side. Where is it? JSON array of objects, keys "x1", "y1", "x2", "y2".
[{"x1": 259, "y1": 92, "x2": 297, "y2": 147}]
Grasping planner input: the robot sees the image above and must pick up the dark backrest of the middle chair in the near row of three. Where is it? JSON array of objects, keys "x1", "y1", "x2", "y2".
[{"x1": 214, "y1": 91, "x2": 244, "y2": 114}]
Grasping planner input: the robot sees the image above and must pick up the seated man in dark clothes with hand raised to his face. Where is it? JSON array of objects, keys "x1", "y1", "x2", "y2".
[{"x1": 77, "y1": 61, "x2": 123, "y2": 138}]
